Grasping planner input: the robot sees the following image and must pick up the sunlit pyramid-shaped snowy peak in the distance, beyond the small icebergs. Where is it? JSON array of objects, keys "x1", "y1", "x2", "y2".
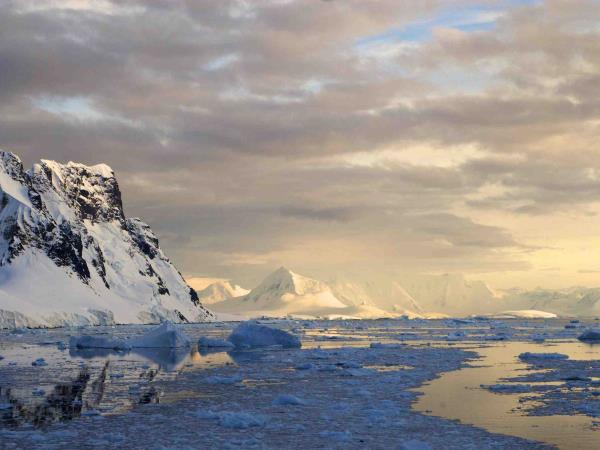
[{"x1": 211, "y1": 267, "x2": 393, "y2": 318}]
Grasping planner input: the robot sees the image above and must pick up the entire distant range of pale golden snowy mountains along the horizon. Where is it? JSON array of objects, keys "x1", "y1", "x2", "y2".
[{"x1": 205, "y1": 267, "x2": 600, "y2": 319}]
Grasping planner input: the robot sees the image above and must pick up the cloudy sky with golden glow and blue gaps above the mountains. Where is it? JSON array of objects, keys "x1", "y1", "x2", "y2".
[{"x1": 0, "y1": 0, "x2": 600, "y2": 288}]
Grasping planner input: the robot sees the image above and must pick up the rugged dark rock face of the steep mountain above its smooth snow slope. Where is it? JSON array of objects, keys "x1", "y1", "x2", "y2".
[{"x1": 0, "y1": 151, "x2": 211, "y2": 321}]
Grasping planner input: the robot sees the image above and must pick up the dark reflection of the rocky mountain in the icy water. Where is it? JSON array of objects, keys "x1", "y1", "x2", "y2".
[{"x1": 0, "y1": 345, "x2": 234, "y2": 428}]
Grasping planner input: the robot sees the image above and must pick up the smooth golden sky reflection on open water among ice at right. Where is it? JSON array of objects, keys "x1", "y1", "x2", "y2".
[{"x1": 413, "y1": 342, "x2": 600, "y2": 450}]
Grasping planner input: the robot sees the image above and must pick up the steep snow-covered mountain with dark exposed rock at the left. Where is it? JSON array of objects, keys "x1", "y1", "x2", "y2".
[{"x1": 0, "y1": 152, "x2": 213, "y2": 327}]
